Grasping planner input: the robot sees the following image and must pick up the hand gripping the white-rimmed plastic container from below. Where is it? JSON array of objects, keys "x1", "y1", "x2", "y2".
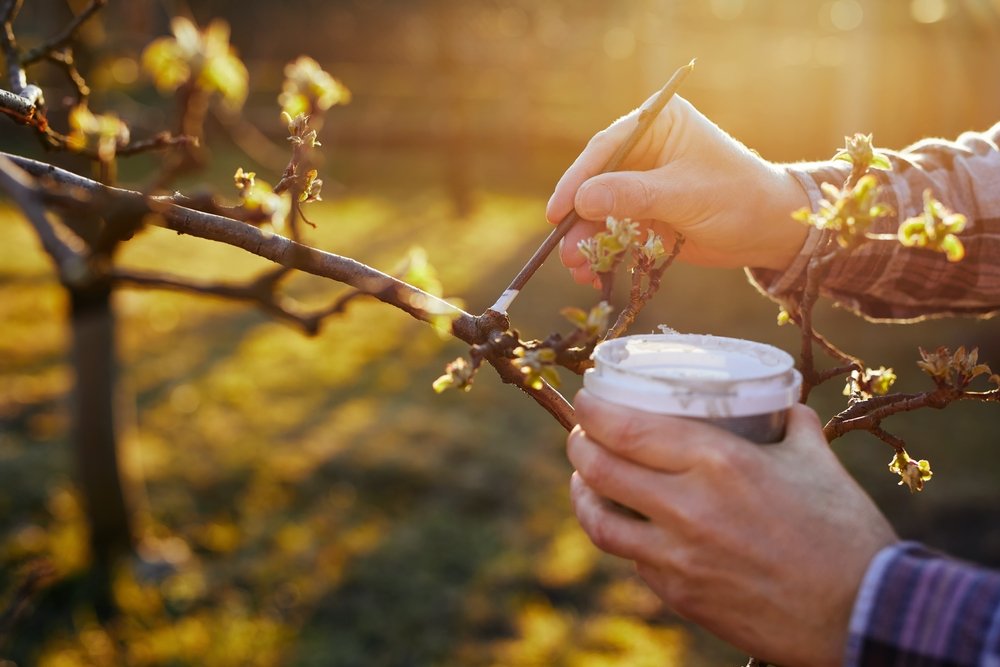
[{"x1": 568, "y1": 390, "x2": 897, "y2": 666}]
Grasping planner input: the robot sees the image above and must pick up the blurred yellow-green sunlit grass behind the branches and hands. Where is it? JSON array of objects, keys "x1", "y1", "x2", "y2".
[{"x1": 0, "y1": 180, "x2": 1000, "y2": 667}]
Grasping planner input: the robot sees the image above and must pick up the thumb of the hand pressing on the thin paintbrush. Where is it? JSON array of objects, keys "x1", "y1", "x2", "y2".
[{"x1": 575, "y1": 171, "x2": 665, "y2": 220}]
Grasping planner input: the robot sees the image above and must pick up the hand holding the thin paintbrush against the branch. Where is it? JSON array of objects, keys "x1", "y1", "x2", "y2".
[{"x1": 546, "y1": 97, "x2": 809, "y2": 283}]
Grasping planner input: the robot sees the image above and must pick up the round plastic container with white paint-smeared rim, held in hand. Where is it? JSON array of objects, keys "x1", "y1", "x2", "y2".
[{"x1": 583, "y1": 333, "x2": 802, "y2": 444}]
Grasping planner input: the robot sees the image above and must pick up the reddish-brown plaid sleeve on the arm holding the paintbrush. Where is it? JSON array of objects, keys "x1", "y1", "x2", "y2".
[{"x1": 748, "y1": 123, "x2": 1000, "y2": 321}]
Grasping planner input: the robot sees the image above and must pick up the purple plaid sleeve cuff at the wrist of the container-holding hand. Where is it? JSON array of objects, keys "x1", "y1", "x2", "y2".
[{"x1": 844, "y1": 542, "x2": 1000, "y2": 667}]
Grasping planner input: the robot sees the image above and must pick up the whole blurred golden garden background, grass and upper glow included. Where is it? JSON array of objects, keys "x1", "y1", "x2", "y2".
[{"x1": 0, "y1": 0, "x2": 1000, "y2": 666}]
